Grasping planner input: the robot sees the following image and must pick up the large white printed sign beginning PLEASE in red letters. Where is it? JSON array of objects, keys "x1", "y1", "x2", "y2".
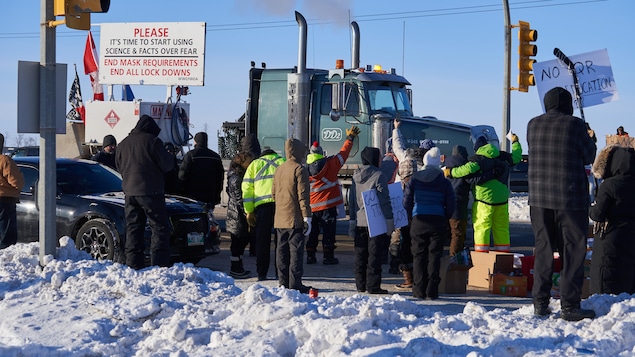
[{"x1": 99, "y1": 22, "x2": 205, "y2": 86}]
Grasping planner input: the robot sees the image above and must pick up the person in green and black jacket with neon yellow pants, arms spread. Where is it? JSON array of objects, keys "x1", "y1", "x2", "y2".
[{"x1": 445, "y1": 134, "x2": 523, "y2": 252}]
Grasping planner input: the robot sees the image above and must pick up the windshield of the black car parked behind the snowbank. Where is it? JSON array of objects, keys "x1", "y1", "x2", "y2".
[{"x1": 57, "y1": 161, "x2": 121, "y2": 195}]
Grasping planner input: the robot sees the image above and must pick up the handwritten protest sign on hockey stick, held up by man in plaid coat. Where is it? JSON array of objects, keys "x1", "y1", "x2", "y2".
[{"x1": 534, "y1": 49, "x2": 619, "y2": 111}]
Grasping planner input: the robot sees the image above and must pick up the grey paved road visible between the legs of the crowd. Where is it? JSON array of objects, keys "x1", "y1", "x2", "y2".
[{"x1": 197, "y1": 208, "x2": 533, "y2": 314}]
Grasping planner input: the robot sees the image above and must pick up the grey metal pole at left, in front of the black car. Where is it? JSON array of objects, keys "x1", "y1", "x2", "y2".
[{"x1": 36, "y1": 0, "x2": 57, "y2": 266}]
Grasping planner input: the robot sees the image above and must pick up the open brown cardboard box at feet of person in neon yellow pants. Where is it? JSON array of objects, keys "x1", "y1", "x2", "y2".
[{"x1": 468, "y1": 252, "x2": 514, "y2": 289}]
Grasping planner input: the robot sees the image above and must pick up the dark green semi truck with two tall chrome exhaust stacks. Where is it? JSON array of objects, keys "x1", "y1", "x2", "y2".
[{"x1": 219, "y1": 12, "x2": 499, "y2": 177}]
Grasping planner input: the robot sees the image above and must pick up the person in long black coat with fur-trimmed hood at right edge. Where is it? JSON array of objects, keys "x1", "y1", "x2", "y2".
[{"x1": 589, "y1": 145, "x2": 635, "y2": 295}]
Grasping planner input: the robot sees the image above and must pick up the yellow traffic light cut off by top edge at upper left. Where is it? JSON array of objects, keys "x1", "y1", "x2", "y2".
[{"x1": 53, "y1": 0, "x2": 110, "y2": 30}]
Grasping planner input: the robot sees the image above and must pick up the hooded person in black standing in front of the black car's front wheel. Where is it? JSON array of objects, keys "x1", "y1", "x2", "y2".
[{"x1": 115, "y1": 115, "x2": 174, "y2": 269}]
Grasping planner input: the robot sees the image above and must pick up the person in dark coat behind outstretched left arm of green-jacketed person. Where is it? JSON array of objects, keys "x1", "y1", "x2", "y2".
[{"x1": 445, "y1": 145, "x2": 471, "y2": 256}]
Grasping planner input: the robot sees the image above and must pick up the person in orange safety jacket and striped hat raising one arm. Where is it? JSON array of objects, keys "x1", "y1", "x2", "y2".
[{"x1": 306, "y1": 125, "x2": 359, "y2": 265}]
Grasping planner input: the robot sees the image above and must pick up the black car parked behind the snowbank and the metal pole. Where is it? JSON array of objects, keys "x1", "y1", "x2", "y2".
[{"x1": 14, "y1": 157, "x2": 220, "y2": 262}]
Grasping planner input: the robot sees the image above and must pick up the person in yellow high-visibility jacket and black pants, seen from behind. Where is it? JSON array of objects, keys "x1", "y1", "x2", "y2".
[{"x1": 241, "y1": 143, "x2": 285, "y2": 281}]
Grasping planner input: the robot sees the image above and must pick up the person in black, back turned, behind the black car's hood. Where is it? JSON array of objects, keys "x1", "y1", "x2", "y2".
[{"x1": 179, "y1": 132, "x2": 225, "y2": 207}]
